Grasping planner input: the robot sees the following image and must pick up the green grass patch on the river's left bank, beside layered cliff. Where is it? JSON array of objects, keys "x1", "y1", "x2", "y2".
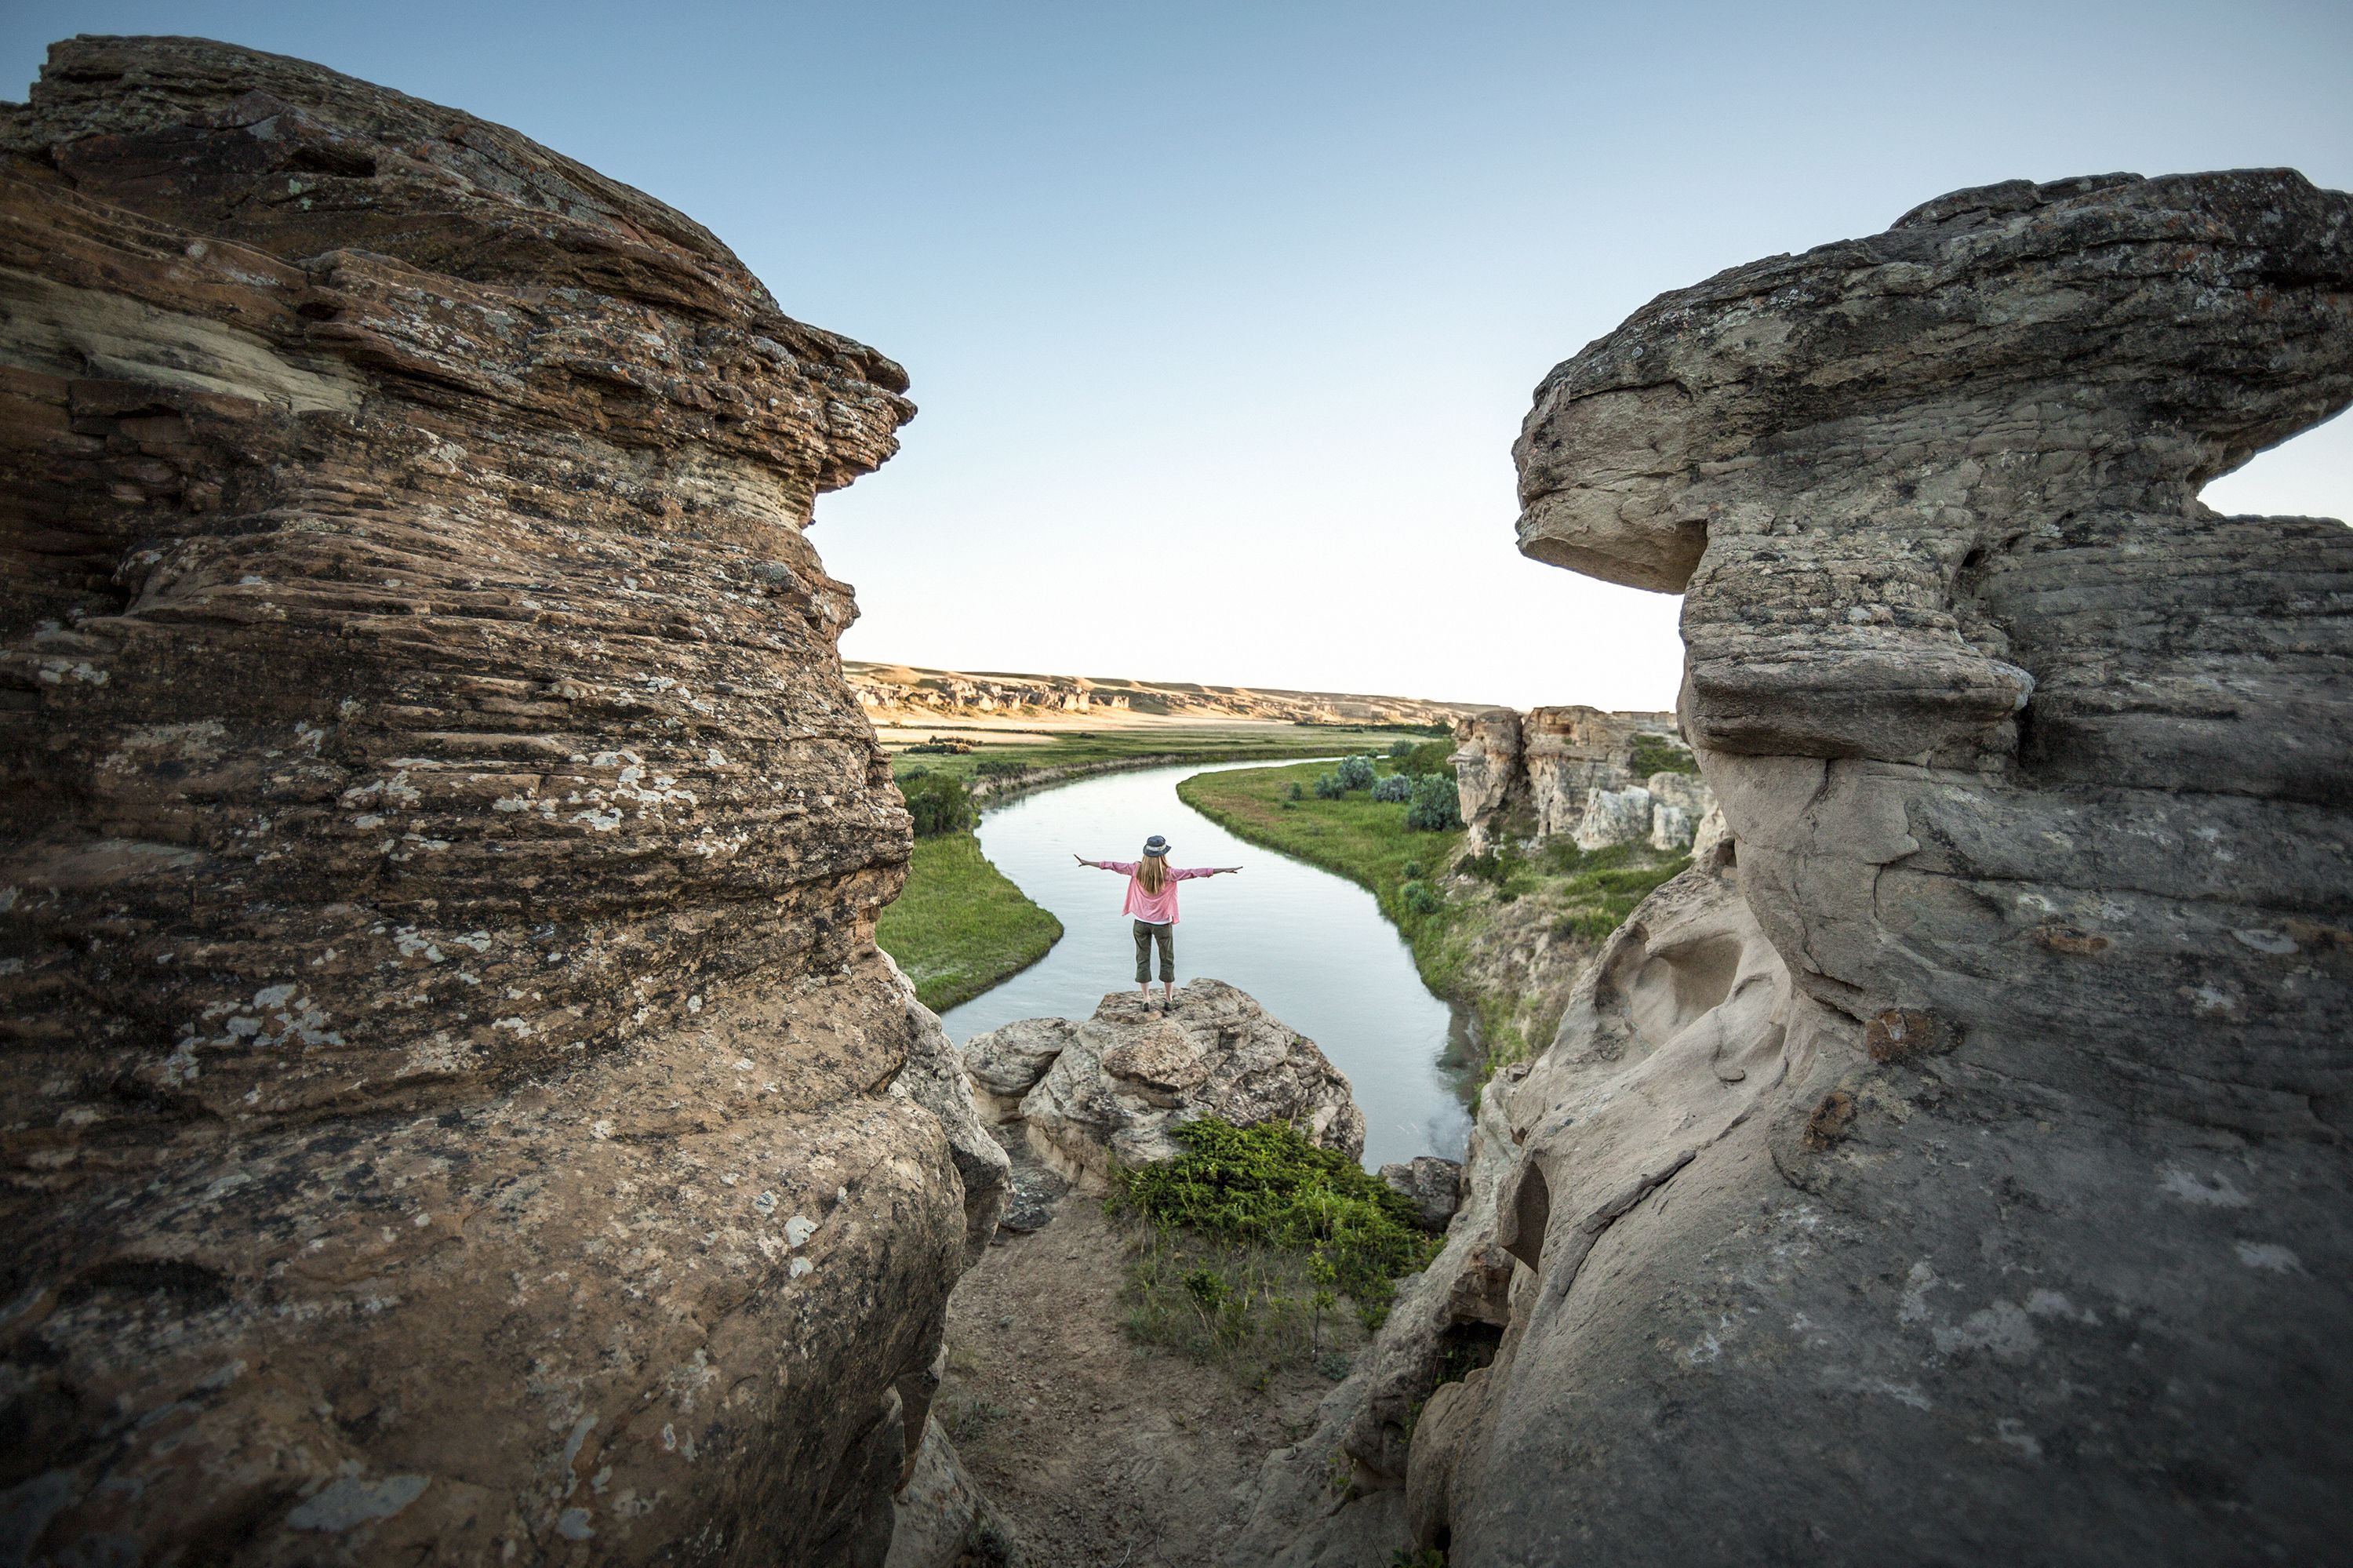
[{"x1": 875, "y1": 834, "x2": 1061, "y2": 1013}]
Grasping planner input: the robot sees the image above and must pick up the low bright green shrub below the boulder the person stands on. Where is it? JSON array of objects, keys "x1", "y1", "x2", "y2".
[{"x1": 1111, "y1": 1116, "x2": 1438, "y2": 1309}]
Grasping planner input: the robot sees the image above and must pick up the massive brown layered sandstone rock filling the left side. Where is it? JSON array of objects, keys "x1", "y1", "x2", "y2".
[{"x1": 0, "y1": 38, "x2": 1002, "y2": 1563}]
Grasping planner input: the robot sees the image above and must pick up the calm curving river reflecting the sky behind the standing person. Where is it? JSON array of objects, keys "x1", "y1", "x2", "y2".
[{"x1": 944, "y1": 762, "x2": 1471, "y2": 1166}]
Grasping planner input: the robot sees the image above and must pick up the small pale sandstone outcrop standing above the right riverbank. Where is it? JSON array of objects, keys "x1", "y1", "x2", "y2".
[{"x1": 1454, "y1": 706, "x2": 1715, "y2": 855}]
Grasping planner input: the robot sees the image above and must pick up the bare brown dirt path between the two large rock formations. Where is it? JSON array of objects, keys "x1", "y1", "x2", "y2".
[{"x1": 934, "y1": 1194, "x2": 1332, "y2": 1568}]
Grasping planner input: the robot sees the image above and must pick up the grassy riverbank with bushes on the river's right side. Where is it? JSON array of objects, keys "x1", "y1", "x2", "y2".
[{"x1": 1176, "y1": 762, "x2": 1692, "y2": 1076}]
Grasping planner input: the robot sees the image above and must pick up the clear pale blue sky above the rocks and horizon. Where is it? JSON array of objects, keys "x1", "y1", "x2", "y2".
[{"x1": 0, "y1": 0, "x2": 2353, "y2": 706}]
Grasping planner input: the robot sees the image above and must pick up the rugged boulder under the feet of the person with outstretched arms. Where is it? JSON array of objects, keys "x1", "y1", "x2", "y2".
[{"x1": 965, "y1": 980, "x2": 1365, "y2": 1189}]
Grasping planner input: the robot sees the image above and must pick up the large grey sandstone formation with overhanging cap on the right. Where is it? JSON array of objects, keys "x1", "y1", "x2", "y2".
[{"x1": 1268, "y1": 172, "x2": 2353, "y2": 1568}]
